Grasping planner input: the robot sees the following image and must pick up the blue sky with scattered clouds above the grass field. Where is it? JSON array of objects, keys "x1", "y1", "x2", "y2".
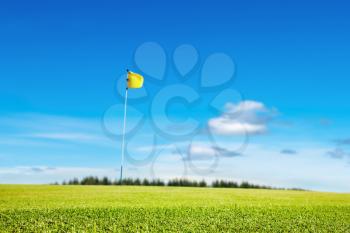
[{"x1": 0, "y1": 1, "x2": 350, "y2": 192}]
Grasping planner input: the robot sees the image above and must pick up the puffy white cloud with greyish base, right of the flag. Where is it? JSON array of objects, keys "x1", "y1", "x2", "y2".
[{"x1": 208, "y1": 100, "x2": 275, "y2": 135}]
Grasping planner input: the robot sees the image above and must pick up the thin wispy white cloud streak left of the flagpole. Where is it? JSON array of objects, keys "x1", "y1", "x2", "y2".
[{"x1": 0, "y1": 114, "x2": 110, "y2": 146}]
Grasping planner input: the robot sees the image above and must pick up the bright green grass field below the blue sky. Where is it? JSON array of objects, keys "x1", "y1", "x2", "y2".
[{"x1": 0, "y1": 185, "x2": 350, "y2": 232}]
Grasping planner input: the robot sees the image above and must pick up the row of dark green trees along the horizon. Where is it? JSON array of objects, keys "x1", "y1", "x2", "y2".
[{"x1": 55, "y1": 176, "x2": 302, "y2": 190}]
